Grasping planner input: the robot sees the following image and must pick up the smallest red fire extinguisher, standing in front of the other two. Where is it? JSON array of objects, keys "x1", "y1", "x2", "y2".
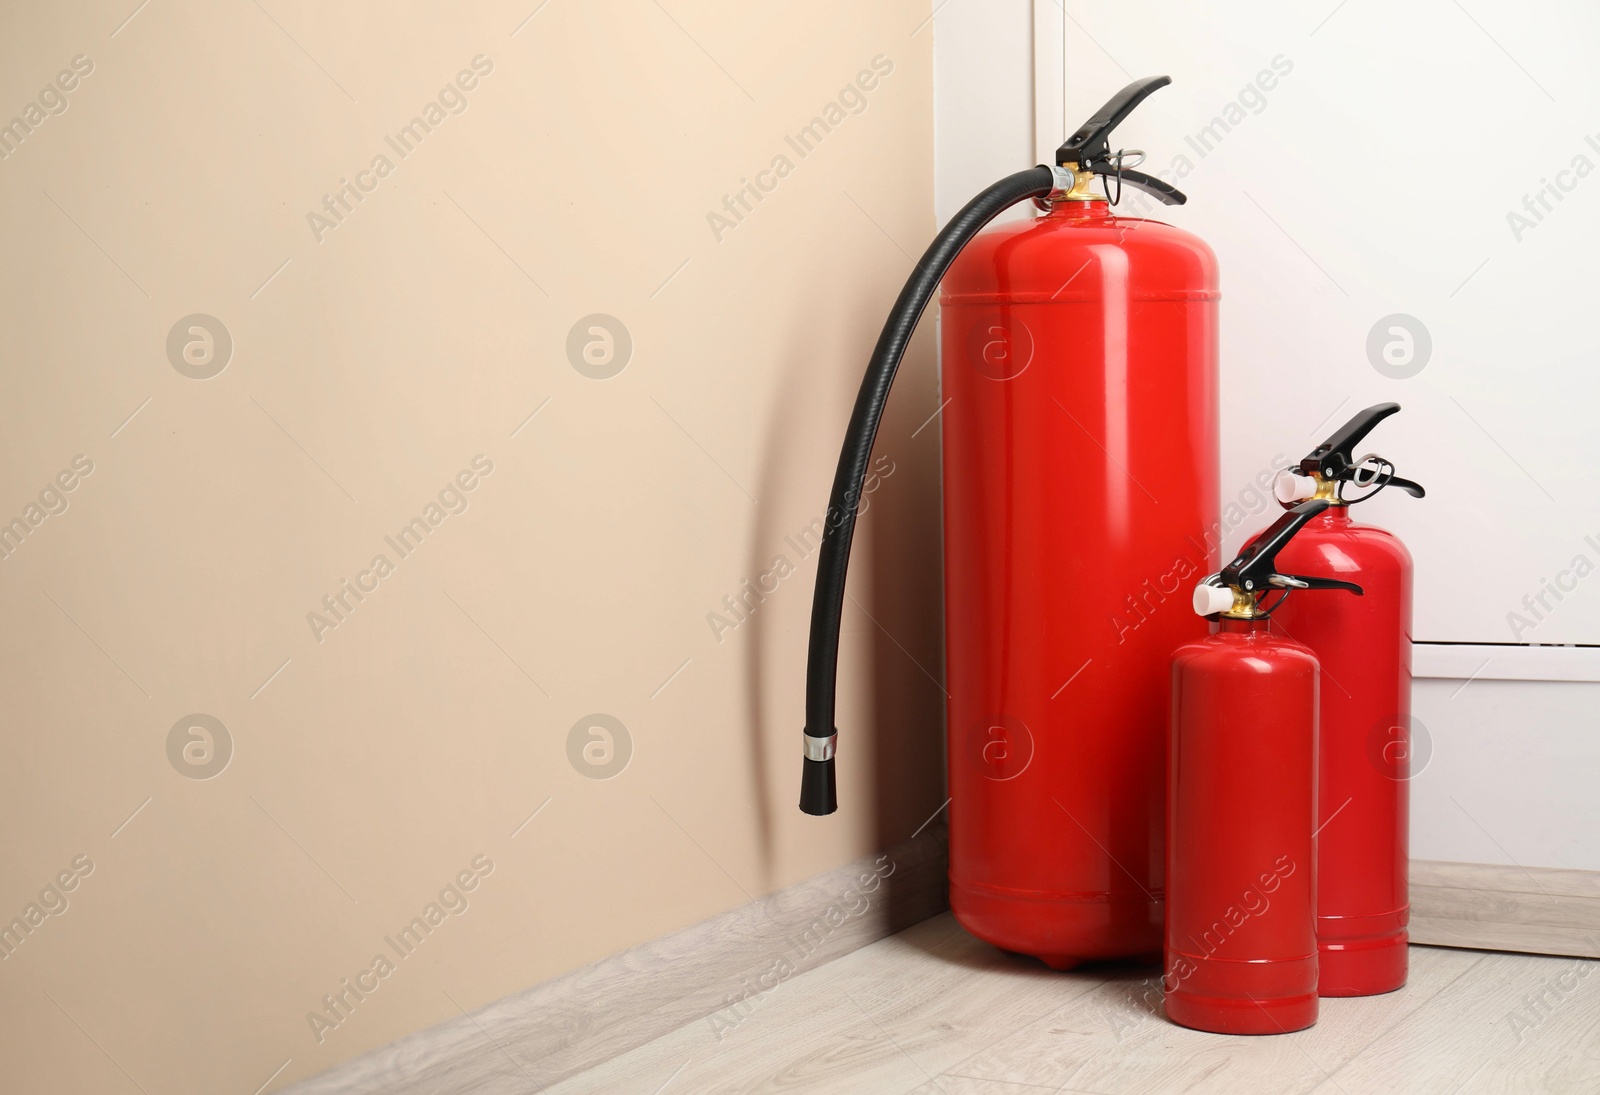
[{"x1": 1162, "y1": 499, "x2": 1362, "y2": 1034}]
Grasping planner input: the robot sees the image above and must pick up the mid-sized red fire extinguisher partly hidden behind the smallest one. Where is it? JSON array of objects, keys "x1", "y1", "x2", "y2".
[{"x1": 1274, "y1": 403, "x2": 1424, "y2": 996}]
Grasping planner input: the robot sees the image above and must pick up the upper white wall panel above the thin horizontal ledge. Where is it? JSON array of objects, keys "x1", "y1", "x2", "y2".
[{"x1": 1067, "y1": 0, "x2": 1600, "y2": 644}]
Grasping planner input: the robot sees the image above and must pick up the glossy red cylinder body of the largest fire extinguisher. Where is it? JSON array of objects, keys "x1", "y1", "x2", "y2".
[{"x1": 941, "y1": 202, "x2": 1218, "y2": 969}]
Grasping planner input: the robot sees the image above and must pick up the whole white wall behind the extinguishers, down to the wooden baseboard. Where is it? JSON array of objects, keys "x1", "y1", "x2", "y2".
[{"x1": 934, "y1": 0, "x2": 1600, "y2": 869}]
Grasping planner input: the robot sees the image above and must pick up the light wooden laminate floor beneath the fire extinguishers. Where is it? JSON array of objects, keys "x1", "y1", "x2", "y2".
[{"x1": 540, "y1": 914, "x2": 1600, "y2": 1095}]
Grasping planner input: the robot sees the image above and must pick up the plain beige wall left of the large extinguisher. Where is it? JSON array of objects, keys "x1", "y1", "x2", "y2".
[{"x1": 0, "y1": 0, "x2": 941, "y2": 1095}]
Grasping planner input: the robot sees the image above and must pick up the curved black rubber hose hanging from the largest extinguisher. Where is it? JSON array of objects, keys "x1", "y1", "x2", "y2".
[{"x1": 800, "y1": 166, "x2": 1054, "y2": 815}]
